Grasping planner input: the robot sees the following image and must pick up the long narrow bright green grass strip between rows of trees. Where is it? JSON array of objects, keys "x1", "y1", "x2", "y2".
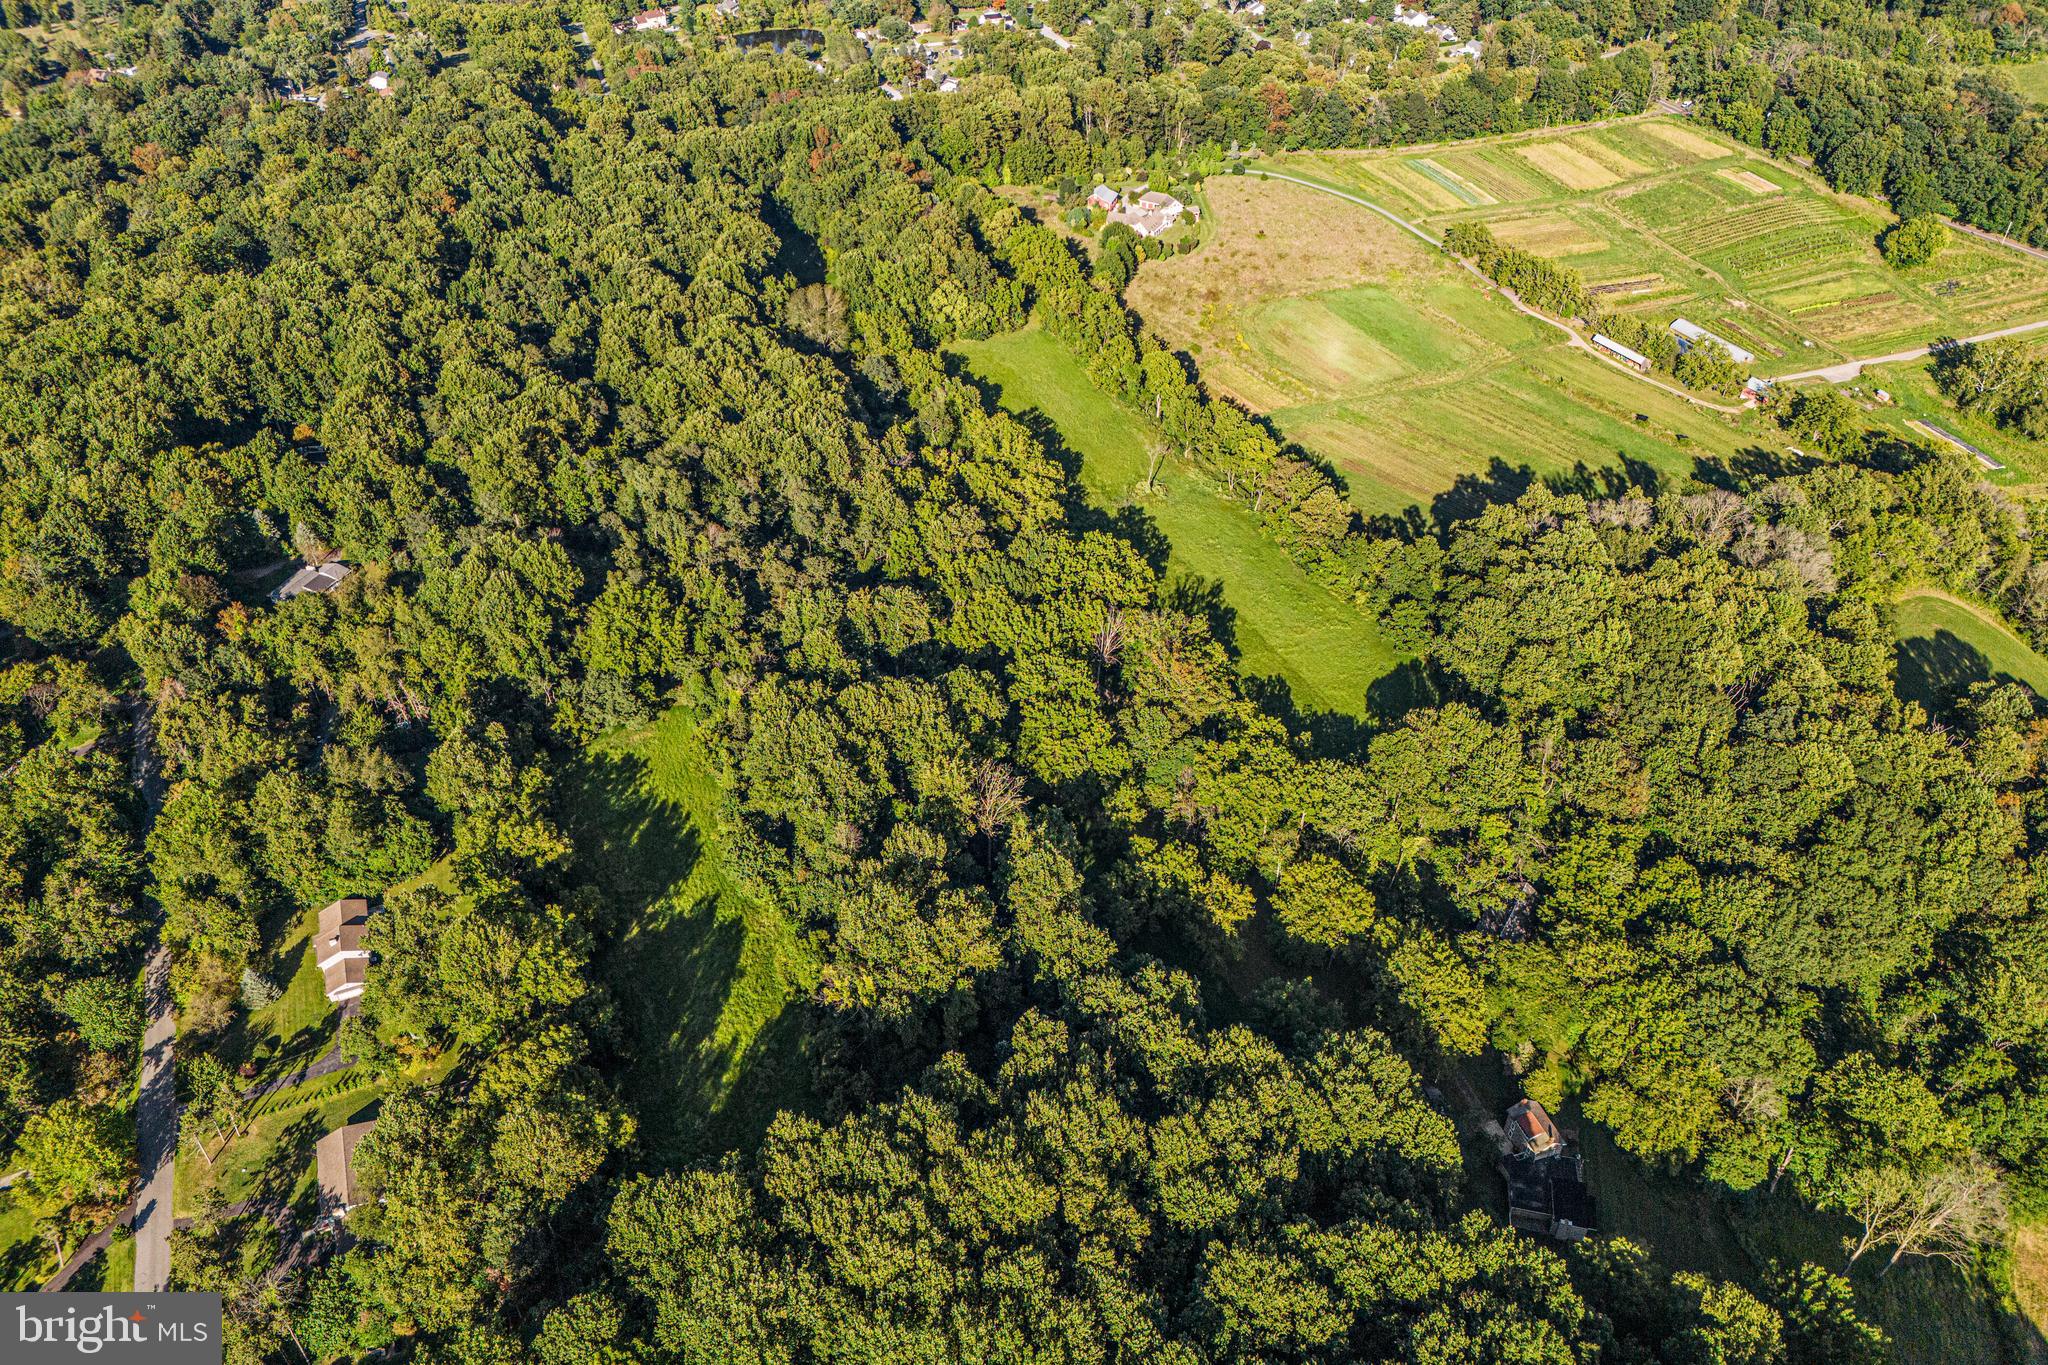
[{"x1": 954, "y1": 327, "x2": 1397, "y2": 716}]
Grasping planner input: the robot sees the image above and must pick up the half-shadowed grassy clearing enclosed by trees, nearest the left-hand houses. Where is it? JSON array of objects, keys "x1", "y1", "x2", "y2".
[{"x1": 567, "y1": 706, "x2": 817, "y2": 1160}]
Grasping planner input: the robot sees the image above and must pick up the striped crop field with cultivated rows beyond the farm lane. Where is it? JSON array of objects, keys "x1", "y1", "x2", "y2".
[{"x1": 1272, "y1": 119, "x2": 2048, "y2": 362}]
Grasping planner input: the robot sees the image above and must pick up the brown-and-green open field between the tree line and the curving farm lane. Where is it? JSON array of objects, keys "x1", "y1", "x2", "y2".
[{"x1": 1126, "y1": 176, "x2": 1780, "y2": 514}]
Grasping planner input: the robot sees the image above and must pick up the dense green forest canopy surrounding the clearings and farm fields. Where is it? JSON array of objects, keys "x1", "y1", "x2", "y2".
[{"x1": 0, "y1": 0, "x2": 2048, "y2": 1363}]
